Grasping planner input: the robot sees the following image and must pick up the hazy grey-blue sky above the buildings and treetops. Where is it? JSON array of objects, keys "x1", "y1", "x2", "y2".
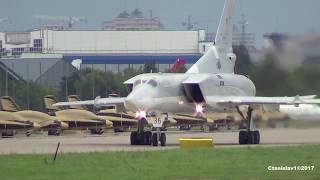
[{"x1": 0, "y1": 0, "x2": 320, "y2": 46}]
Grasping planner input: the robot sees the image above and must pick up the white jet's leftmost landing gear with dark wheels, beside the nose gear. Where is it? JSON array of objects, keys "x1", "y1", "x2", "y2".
[{"x1": 130, "y1": 118, "x2": 153, "y2": 145}]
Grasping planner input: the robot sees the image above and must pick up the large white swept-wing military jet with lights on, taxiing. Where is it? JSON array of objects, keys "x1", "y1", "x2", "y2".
[{"x1": 55, "y1": 0, "x2": 320, "y2": 146}]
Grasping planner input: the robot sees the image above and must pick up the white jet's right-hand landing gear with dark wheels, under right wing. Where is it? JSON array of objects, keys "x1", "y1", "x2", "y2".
[{"x1": 236, "y1": 106, "x2": 260, "y2": 144}]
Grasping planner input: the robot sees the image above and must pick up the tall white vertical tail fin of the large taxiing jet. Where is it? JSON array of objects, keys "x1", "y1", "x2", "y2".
[{"x1": 187, "y1": 0, "x2": 236, "y2": 73}]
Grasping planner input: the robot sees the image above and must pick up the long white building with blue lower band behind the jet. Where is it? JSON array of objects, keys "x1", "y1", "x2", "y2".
[{"x1": 0, "y1": 30, "x2": 205, "y2": 74}]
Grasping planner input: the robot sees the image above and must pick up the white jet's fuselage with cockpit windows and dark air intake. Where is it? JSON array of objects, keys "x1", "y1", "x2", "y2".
[{"x1": 125, "y1": 73, "x2": 255, "y2": 113}]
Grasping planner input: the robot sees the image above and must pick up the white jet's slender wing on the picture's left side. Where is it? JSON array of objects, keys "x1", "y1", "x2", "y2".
[{"x1": 53, "y1": 96, "x2": 125, "y2": 106}]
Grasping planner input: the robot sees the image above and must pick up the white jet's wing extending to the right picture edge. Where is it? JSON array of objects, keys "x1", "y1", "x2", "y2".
[{"x1": 206, "y1": 96, "x2": 320, "y2": 106}]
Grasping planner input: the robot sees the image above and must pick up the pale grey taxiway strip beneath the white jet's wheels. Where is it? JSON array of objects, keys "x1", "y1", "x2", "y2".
[{"x1": 0, "y1": 128, "x2": 320, "y2": 154}]
